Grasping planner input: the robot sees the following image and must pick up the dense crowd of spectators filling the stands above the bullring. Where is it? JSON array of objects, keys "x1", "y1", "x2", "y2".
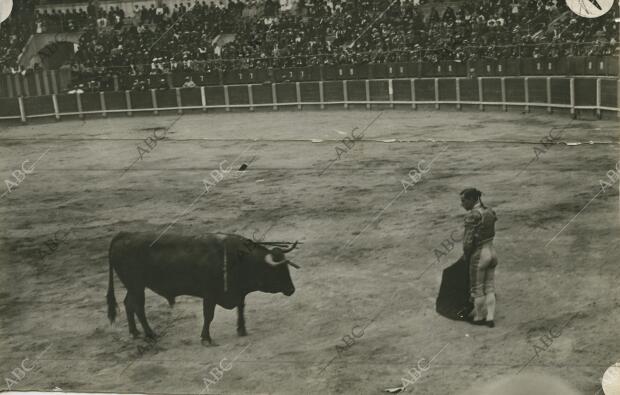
[{"x1": 0, "y1": 0, "x2": 618, "y2": 89}]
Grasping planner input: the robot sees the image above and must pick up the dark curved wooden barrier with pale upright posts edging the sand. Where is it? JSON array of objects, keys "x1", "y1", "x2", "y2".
[{"x1": 0, "y1": 76, "x2": 620, "y2": 122}]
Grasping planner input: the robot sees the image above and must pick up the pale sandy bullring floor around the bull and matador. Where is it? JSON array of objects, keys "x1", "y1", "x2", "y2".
[{"x1": 0, "y1": 110, "x2": 620, "y2": 394}]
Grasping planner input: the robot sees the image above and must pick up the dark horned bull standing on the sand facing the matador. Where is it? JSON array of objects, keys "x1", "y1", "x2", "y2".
[{"x1": 106, "y1": 232, "x2": 299, "y2": 346}]
